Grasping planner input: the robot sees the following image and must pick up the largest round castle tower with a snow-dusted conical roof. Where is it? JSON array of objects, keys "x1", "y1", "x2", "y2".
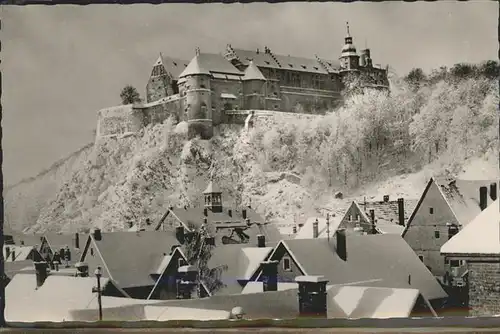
[{"x1": 179, "y1": 48, "x2": 213, "y2": 139}]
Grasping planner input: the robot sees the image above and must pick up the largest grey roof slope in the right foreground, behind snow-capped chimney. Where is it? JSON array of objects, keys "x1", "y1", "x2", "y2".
[{"x1": 283, "y1": 234, "x2": 446, "y2": 300}]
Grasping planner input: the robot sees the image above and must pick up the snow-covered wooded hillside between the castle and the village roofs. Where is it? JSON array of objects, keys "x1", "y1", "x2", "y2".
[{"x1": 5, "y1": 74, "x2": 499, "y2": 232}]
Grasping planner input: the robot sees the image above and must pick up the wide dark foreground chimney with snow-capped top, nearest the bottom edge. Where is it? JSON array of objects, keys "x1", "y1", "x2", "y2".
[{"x1": 295, "y1": 276, "x2": 328, "y2": 318}]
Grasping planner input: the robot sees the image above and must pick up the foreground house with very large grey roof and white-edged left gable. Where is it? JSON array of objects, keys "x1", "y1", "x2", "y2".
[{"x1": 248, "y1": 230, "x2": 448, "y2": 304}]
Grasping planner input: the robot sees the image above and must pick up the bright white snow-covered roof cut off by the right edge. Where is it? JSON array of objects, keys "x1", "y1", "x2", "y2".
[{"x1": 441, "y1": 200, "x2": 500, "y2": 256}]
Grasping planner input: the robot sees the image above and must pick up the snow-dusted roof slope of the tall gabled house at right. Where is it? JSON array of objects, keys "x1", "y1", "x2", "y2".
[{"x1": 436, "y1": 179, "x2": 498, "y2": 225}]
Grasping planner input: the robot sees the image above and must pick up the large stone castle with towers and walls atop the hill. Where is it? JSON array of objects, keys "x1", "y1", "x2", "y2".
[{"x1": 96, "y1": 26, "x2": 389, "y2": 139}]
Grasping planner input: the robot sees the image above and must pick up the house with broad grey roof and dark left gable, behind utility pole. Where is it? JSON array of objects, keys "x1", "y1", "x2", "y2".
[{"x1": 80, "y1": 229, "x2": 184, "y2": 299}]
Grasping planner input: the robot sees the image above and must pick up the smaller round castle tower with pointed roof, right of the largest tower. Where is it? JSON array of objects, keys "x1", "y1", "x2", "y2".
[{"x1": 241, "y1": 60, "x2": 266, "y2": 109}]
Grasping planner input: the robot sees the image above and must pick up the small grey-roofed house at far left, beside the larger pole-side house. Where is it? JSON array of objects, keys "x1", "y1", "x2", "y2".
[{"x1": 40, "y1": 233, "x2": 86, "y2": 264}]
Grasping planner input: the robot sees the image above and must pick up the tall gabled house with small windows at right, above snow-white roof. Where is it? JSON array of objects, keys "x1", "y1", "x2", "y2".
[{"x1": 403, "y1": 178, "x2": 498, "y2": 285}]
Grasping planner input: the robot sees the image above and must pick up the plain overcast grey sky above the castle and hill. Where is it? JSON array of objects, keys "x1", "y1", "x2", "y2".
[{"x1": 0, "y1": 1, "x2": 498, "y2": 185}]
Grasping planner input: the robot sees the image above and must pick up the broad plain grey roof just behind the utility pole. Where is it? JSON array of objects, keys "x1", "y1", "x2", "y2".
[{"x1": 89, "y1": 231, "x2": 179, "y2": 288}]
